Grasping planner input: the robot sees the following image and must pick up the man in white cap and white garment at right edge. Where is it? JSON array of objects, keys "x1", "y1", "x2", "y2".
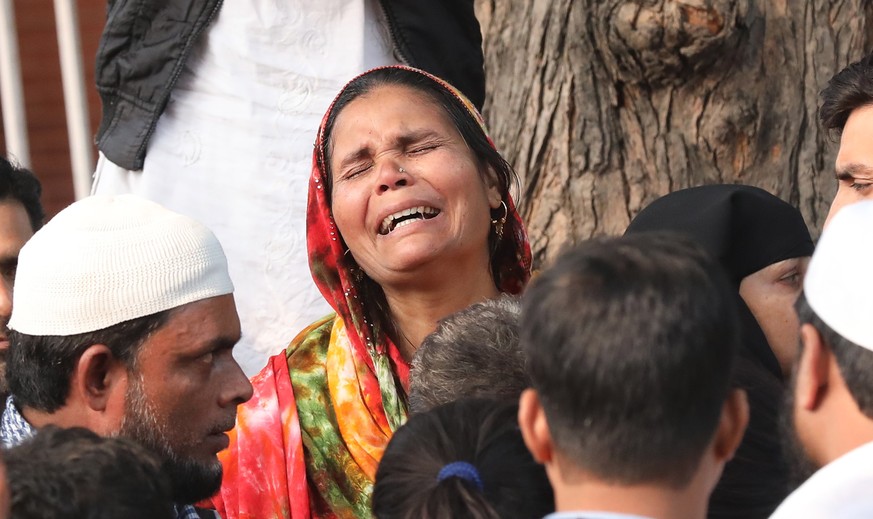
[{"x1": 771, "y1": 201, "x2": 873, "y2": 519}]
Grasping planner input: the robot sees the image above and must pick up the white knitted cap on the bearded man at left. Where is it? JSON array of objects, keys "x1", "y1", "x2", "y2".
[{"x1": 9, "y1": 195, "x2": 233, "y2": 335}]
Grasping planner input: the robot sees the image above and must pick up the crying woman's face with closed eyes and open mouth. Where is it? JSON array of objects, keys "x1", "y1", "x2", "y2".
[{"x1": 328, "y1": 85, "x2": 501, "y2": 286}]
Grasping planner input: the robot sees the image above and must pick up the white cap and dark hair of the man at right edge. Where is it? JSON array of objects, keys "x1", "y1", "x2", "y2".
[{"x1": 797, "y1": 201, "x2": 873, "y2": 418}]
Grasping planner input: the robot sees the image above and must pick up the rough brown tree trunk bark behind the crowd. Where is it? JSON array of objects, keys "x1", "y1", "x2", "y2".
[{"x1": 476, "y1": 0, "x2": 873, "y2": 265}]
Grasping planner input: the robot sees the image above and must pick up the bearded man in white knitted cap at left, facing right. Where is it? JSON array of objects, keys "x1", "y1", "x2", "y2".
[{"x1": 0, "y1": 195, "x2": 252, "y2": 519}]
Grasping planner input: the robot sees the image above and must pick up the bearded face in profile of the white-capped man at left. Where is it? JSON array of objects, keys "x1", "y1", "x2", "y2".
[{"x1": 118, "y1": 295, "x2": 252, "y2": 503}]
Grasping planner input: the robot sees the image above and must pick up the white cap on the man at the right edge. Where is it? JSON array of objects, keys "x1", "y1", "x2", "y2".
[{"x1": 803, "y1": 201, "x2": 873, "y2": 350}]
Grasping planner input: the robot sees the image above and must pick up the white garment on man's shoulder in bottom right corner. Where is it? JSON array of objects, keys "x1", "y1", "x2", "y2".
[{"x1": 770, "y1": 442, "x2": 873, "y2": 519}]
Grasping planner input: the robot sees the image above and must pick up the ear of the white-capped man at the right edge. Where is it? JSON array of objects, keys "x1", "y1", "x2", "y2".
[{"x1": 794, "y1": 323, "x2": 833, "y2": 411}]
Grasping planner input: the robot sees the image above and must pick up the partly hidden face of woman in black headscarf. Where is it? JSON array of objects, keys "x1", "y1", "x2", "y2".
[{"x1": 740, "y1": 256, "x2": 809, "y2": 379}]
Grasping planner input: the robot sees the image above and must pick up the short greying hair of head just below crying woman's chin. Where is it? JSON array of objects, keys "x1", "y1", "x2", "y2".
[{"x1": 409, "y1": 295, "x2": 530, "y2": 413}]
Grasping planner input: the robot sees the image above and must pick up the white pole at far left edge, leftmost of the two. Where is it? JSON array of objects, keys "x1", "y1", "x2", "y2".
[{"x1": 0, "y1": 0, "x2": 30, "y2": 167}]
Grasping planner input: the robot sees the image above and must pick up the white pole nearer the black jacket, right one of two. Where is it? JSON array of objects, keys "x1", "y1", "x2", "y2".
[{"x1": 55, "y1": 0, "x2": 94, "y2": 200}]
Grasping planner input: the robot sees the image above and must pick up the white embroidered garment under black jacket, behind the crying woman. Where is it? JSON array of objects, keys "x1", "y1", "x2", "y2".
[{"x1": 94, "y1": 0, "x2": 397, "y2": 375}]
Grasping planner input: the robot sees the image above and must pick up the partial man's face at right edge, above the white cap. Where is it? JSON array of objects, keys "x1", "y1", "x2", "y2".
[{"x1": 825, "y1": 105, "x2": 873, "y2": 226}]
